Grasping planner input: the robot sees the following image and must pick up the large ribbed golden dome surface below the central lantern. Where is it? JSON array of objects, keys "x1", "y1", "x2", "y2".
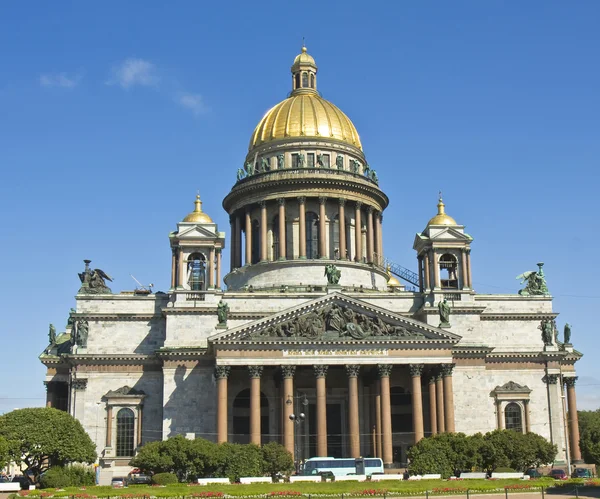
[{"x1": 248, "y1": 92, "x2": 362, "y2": 150}]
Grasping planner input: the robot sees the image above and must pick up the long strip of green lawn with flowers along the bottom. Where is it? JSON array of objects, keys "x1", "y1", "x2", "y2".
[{"x1": 14, "y1": 478, "x2": 600, "y2": 499}]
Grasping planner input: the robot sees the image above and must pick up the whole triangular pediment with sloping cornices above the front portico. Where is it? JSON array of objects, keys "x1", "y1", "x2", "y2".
[{"x1": 209, "y1": 293, "x2": 461, "y2": 344}]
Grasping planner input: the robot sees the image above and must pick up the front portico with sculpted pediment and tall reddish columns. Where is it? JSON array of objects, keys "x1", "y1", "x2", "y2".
[{"x1": 209, "y1": 293, "x2": 460, "y2": 465}]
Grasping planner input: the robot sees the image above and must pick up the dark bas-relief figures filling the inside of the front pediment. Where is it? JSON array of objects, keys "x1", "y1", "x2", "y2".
[{"x1": 246, "y1": 303, "x2": 427, "y2": 341}]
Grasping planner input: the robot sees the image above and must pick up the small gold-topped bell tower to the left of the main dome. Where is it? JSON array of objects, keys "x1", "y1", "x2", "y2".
[{"x1": 169, "y1": 194, "x2": 225, "y2": 292}]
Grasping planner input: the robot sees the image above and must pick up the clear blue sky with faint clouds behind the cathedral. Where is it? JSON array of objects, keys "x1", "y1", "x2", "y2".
[{"x1": 0, "y1": 0, "x2": 600, "y2": 412}]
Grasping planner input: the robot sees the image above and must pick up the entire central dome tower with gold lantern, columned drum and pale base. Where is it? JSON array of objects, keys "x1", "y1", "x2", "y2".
[{"x1": 223, "y1": 47, "x2": 389, "y2": 289}]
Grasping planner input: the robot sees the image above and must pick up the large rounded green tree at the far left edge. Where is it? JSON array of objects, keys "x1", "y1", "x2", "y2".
[{"x1": 0, "y1": 407, "x2": 96, "y2": 482}]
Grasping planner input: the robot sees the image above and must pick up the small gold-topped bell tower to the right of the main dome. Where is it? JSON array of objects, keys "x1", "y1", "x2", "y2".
[{"x1": 413, "y1": 193, "x2": 473, "y2": 299}]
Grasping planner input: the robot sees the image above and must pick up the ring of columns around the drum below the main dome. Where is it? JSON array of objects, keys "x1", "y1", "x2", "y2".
[{"x1": 229, "y1": 196, "x2": 383, "y2": 270}]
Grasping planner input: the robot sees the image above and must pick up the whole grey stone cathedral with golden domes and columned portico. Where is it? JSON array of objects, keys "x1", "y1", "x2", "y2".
[{"x1": 40, "y1": 47, "x2": 581, "y2": 481}]
